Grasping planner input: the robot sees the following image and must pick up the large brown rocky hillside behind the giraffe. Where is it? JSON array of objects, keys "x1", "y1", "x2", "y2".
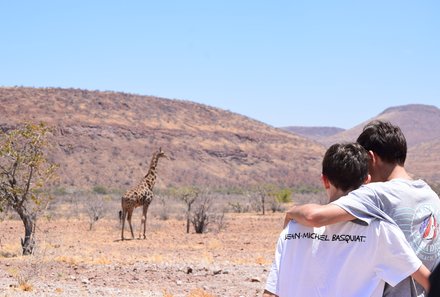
[{"x1": 0, "y1": 88, "x2": 324, "y2": 189}]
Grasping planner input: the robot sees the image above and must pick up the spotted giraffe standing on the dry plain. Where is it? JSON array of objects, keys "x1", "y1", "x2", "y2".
[{"x1": 121, "y1": 148, "x2": 168, "y2": 240}]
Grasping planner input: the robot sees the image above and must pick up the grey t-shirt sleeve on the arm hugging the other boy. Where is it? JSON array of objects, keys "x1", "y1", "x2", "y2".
[{"x1": 331, "y1": 186, "x2": 396, "y2": 225}]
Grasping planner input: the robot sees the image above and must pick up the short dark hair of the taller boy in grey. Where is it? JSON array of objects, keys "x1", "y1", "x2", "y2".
[{"x1": 357, "y1": 120, "x2": 407, "y2": 166}]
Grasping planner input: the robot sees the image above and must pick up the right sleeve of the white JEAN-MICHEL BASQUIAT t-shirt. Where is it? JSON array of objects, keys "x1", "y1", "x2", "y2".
[{"x1": 376, "y1": 221, "x2": 422, "y2": 287}]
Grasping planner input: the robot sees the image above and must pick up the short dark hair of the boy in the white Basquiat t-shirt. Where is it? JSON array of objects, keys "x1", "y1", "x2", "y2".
[{"x1": 322, "y1": 143, "x2": 369, "y2": 191}]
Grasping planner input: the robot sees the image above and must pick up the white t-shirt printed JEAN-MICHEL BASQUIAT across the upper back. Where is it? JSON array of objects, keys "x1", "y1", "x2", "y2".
[{"x1": 266, "y1": 220, "x2": 422, "y2": 297}]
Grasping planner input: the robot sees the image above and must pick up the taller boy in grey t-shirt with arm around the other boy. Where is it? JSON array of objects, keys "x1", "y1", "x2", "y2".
[{"x1": 286, "y1": 121, "x2": 440, "y2": 297}]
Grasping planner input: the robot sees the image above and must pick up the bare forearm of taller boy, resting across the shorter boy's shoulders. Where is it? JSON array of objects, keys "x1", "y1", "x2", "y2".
[{"x1": 284, "y1": 204, "x2": 355, "y2": 227}]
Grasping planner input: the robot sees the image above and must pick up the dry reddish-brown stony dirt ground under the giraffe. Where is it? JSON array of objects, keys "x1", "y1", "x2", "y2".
[{"x1": 0, "y1": 213, "x2": 284, "y2": 297}]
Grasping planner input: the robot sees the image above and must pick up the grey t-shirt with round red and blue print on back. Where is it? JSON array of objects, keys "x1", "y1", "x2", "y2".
[{"x1": 332, "y1": 179, "x2": 440, "y2": 297}]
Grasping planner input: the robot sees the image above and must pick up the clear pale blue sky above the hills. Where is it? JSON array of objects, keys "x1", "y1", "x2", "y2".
[{"x1": 0, "y1": 0, "x2": 440, "y2": 129}]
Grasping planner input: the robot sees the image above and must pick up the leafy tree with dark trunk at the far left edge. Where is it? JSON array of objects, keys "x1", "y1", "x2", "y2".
[{"x1": 0, "y1": 123, "x2": 57, "y2": 255}]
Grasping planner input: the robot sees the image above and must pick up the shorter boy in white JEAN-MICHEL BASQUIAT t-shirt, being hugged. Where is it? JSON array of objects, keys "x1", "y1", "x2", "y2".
[{"x1": 263, "y1": 143, "x2": 429, "y2": 297}]
